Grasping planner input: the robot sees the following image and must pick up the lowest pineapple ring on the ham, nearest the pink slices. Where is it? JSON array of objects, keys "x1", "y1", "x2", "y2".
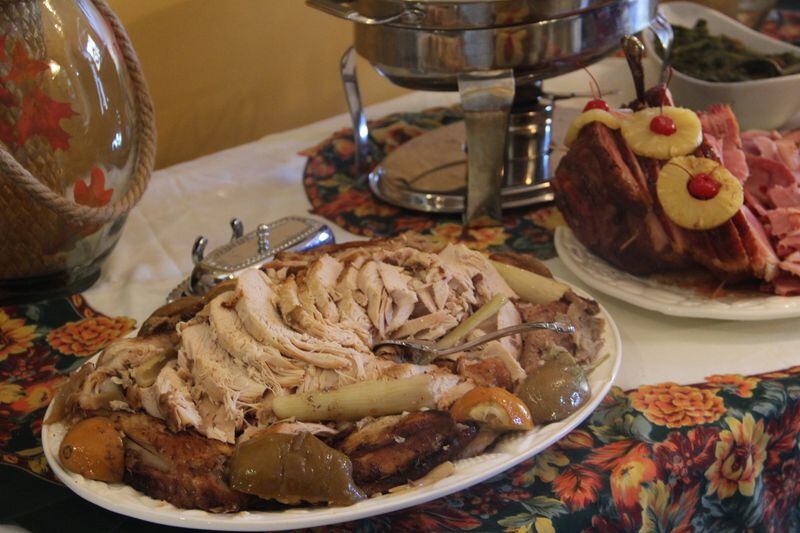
[{"x1": 656, "y1": 156, "x2": 744, "y2": 230}]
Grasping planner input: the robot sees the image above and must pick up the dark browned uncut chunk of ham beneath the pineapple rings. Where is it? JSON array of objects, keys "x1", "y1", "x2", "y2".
[{"x1": 553, "y1": 102, "x2": 753, "y2": 280}]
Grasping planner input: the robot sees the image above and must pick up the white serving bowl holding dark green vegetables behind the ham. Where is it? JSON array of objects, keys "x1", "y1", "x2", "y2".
[{"x1": 645, "y1": 2, "x2": 800, "y2": 130}]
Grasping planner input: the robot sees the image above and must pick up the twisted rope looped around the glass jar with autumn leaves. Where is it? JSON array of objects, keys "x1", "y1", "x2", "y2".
[{"x1": 0, "y1": 0, "x2": 156, "y2": 226}]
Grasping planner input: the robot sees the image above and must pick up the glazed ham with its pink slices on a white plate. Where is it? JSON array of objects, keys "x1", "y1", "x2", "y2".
[{"x1": 552, "y1": 86, "x2": 800, "y2": 295}]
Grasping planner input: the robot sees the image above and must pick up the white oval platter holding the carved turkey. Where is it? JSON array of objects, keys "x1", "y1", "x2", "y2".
[{"x1": 42, "y1": 282, "x2": 622, "y2": 531}]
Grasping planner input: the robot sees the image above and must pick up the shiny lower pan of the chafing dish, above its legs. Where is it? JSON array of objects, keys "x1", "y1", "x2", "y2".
[{"x1": 355, "y1": 0, "x2": 657, "y2": 91}]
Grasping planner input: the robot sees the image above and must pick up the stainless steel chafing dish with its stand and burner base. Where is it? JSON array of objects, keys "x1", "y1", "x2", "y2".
[{"x1": 307, "y1": 0, "x2": 657, "y2": 225}]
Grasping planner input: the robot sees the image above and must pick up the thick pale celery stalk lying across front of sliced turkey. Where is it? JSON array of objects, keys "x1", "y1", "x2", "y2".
[{"x1": 272, "y1": 374, "x2": 436, "y2": 422}]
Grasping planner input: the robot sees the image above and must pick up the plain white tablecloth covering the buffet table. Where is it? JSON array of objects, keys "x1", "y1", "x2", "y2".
[{"x1": 86, "y1": 59, "x2": 800, "y2": 389}]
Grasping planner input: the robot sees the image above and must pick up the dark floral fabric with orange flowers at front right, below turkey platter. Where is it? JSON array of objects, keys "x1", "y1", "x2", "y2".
[{"x1": 318, "y1": 367, "x2": 800, "y2": 533}]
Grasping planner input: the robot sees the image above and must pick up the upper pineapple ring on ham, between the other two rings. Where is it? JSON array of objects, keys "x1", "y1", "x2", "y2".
[{"x1": 621, "y1": 106, "x2": 703, "y2": 159}]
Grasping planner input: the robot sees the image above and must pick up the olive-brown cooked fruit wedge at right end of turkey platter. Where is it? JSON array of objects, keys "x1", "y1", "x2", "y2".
[{"x1": 516, "y1": 351, "x2": 591, "y2": 424}]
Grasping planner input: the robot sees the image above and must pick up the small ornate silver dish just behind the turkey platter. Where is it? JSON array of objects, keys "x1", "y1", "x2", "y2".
[{"x1": 167, "y1": 217, "x2": 335, "y2": 302}]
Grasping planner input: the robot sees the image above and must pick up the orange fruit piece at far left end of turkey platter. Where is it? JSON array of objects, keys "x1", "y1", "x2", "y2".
[{"x1": 58, "y1": 416, "x2": 125, "y2": 483}]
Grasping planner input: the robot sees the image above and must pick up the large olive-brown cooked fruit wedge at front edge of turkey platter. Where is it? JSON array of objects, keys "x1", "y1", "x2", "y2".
[{"x1": 230, "y1": 433, "x2": 366, "y2": 505}]
